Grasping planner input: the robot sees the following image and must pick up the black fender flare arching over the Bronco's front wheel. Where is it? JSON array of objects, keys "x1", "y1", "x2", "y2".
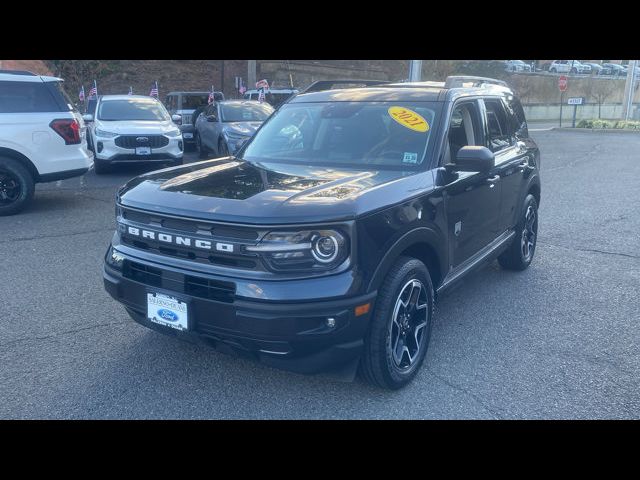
[{"x1": 367, "y1": 227, "x2": 447, "y2": 293}]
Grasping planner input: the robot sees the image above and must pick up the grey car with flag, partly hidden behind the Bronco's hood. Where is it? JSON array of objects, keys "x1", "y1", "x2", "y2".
[{"x1": 195, "y1": 100, "x2": 274, "y2": 158}]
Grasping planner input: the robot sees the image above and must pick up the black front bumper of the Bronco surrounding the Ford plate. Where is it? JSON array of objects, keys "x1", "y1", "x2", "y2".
[{"x1": 104, "y1": 251, "x2": 376, "y2": 373}]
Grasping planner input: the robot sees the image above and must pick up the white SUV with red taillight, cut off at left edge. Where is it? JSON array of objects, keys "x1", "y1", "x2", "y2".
[{"x1": 0, "y1": 70, "x2": 93, "y2": 216}]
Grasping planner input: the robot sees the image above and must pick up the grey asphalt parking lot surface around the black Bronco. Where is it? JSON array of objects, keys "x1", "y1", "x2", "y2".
[{"x1": 0, "y1": 131, "x2": 640, "y2": 419}]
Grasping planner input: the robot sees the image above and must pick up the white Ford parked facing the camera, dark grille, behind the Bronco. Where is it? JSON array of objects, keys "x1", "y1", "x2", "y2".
[{"x1": 84, "y1": 95, "x2": 184, "y2": 174}]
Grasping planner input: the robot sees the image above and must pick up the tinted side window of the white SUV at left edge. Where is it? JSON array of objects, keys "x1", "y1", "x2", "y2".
[{"x1": 0, "y1": 81, "x2": 60, "y2": 113}]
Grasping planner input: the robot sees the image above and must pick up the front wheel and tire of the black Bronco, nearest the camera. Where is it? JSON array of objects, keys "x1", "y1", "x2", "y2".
[{"x1": 360, "y1": 257, "x2": 434, "y2": 390}]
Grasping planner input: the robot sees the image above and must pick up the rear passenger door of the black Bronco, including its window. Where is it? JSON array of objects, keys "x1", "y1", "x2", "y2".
[{"x1": 482, "y1": 95, "x2": 528, "y2": 233}]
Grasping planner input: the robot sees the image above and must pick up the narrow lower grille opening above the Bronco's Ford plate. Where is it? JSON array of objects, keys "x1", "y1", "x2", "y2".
[{"x1": 122, "y1": 260, "x2": 236, "y2": 303}]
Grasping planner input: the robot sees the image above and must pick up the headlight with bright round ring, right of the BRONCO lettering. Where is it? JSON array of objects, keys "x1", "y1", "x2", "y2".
[{"x1": 245, "y1": 230, "x2": 349, "y2": 271}]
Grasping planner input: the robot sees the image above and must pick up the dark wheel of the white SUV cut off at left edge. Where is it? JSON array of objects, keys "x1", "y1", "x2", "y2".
[{"x1": 0, "y1": 157, "x2": 35, "y2": 216}]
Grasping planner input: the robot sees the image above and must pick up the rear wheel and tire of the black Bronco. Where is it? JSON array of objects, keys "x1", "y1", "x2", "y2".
[{"x1": 498, "y1": 194, "x2": 538, "y2": 270}]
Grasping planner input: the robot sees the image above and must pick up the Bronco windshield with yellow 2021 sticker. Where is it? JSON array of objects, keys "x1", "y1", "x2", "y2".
[{"x1": 243, "y1": 102, "x2": 440, "y2": 168}]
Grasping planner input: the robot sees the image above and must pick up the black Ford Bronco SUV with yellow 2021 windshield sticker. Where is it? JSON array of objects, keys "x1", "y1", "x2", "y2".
[{"x1": 104, "y1": 76, "x2": 540, "y2": 388}]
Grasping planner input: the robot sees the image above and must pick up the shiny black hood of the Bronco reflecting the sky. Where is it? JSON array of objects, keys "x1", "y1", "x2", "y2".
[{"x1": 118, "y1": 157, "x2": 433, "y2": 225}]
